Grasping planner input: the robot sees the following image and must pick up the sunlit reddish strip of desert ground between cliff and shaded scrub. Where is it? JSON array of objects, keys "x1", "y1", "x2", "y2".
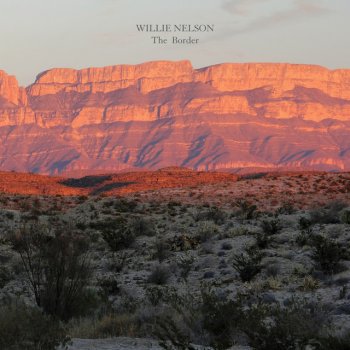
[{"x1": 0, "y1": 167, "x2": 350, "y2": 209}]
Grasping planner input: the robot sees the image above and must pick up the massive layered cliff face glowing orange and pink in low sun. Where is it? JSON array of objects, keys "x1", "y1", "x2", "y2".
[{"x1": 0, "y1": 61, "x2": 350, "y2": 174}]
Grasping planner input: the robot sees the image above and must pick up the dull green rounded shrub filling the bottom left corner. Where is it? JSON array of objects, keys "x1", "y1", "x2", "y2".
[{"x1": 0, "y1": 300, "x2": 68, "y2": 350}]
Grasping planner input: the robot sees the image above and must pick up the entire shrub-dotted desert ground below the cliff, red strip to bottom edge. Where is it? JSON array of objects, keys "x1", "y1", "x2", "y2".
[{"x1": 0, "y1": 168, "x2": 350, "y2": 350}]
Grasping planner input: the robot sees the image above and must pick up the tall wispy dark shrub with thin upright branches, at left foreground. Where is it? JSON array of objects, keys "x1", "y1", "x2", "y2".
[{"x1": 11, "y1": 224, "x2": 93, "y2": 320}]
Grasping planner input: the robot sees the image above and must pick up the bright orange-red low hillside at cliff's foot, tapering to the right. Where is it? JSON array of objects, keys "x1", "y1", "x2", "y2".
[{"x1": 0, "y1": 167, "x2": 238, "y2": 196}]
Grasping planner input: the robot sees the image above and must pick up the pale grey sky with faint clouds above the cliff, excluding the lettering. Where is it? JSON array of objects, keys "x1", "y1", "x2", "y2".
[{"x1": 0, "y1": 0, "x2": 350, "y2": 85}]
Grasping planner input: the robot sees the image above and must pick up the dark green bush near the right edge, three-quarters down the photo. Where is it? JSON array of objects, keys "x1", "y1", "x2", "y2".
[{"x1": 311, "y1": 235, "x2": 345, "y2": 273}]
